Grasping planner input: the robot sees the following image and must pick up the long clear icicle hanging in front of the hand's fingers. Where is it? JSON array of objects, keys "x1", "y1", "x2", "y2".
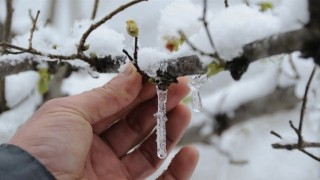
[{"x1": 154, "y1": 85, "x2": 168, "y2": 159}]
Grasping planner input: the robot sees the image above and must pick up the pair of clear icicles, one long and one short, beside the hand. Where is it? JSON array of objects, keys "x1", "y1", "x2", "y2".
[{"x1": 154, "y1": 74, "x2": 207, "y2": 159}]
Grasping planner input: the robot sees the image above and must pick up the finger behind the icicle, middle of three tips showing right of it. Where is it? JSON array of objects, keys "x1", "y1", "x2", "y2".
[{"x1": 122, "y1": 105, "x2": 190, "y2": 179}]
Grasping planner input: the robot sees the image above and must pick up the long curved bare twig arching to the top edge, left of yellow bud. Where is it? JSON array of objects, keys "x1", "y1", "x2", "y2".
[{"x1": 77, "y1": 0, "x2": 148, "y2": 56}]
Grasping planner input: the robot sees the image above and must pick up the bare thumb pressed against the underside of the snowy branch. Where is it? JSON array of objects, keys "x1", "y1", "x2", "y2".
[{"x1": 65, "y1": 63, "x2": 142, "y2": 124}]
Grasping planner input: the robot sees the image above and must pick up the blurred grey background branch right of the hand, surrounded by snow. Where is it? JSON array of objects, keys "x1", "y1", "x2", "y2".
[{"x1": 181, "y1": 86, "x2": 300, "y2": 144}]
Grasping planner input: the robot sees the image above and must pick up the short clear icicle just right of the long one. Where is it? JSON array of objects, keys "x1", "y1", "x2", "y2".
[{"x1": 189, "y1": 74, "x2": 208, "y2": 112}]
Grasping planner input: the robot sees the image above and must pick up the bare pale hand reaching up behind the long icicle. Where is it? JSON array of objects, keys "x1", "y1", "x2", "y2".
[{"x1": 9, "y1": 65, "x2": 199, "y2": 180}]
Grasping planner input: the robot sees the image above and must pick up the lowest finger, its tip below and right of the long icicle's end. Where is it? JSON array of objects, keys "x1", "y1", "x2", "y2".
[{"x1": 157, "y1": 146, "x2": 199, "y2": 180}]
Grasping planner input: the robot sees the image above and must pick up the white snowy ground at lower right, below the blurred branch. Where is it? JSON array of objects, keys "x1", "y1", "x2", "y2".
[{"x1": 149, "y1": 109, "x2": 320, "y2": 180}]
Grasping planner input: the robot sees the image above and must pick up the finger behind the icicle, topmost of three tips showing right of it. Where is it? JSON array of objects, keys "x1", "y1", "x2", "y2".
[{"x1": 100, "y1": 79, "x2": 189, "y2": 157}]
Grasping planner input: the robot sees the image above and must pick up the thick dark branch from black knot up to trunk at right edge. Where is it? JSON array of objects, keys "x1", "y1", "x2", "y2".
[{"x1": 226, "y1": 28, "x2": 320, "y2": 80}]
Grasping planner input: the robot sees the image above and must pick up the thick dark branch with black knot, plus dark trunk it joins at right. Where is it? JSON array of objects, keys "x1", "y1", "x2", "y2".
[{"x1": 225, "y1": 0, "x2": 320, "y2": 80}]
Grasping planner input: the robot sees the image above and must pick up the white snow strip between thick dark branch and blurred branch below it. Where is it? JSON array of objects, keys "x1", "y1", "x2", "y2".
[{"x1": 203, "y1": 63, "x2": 278, "y2": 114}]
